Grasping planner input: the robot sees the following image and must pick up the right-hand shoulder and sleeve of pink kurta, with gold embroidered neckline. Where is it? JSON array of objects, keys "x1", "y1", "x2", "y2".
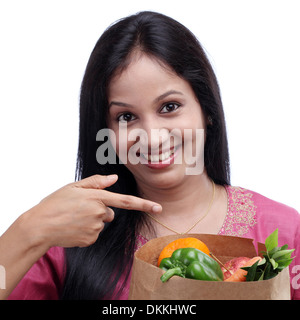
[{"x1": 220, "y1": 186, "x2": 300, "y2": 300}]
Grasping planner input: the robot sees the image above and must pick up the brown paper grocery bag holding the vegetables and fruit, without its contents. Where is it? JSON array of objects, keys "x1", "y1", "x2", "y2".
[{"x1": 129, "y1": 234, "x2": 290, "y2": 300}]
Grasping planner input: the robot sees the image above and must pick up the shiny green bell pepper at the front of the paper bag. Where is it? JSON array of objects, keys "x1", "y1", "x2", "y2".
[{"x1": 159, "y1": 248, "x2": 223, "y2": 282}]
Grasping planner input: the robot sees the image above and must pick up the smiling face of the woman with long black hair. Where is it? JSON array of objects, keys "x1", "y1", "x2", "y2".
[{"x1": 107, "y1": 54, "x2": 205, "y2": 188}]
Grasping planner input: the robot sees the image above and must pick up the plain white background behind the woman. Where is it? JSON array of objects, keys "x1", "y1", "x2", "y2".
[{"x1": 0, "y1": 0, "x2": 300, "y2": 234}]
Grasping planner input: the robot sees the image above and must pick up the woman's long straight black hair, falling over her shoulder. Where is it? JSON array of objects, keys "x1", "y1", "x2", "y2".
[{"x1": 61, "y1": 12, "x2": 230, "y2": 299}]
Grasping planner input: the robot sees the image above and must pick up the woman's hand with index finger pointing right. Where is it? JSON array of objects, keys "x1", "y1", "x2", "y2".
[{"x1": 27, "y1": 175, "x2": 162, "y2": 248}]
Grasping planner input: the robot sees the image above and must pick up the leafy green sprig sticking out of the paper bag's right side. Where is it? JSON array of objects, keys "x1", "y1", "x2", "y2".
[{"x1": 242, "y1": 229, "x2": 295, "y2": 281}]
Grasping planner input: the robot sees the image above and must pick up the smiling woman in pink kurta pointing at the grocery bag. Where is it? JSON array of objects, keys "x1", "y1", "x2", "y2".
[{"x1": 0, "y1": 12, "x2": 300, "y2": 299}]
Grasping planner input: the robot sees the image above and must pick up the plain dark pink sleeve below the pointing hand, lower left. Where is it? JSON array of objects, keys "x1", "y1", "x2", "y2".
[{"x1": 8, "y1": 247, "x2": 64, "y2": 300}]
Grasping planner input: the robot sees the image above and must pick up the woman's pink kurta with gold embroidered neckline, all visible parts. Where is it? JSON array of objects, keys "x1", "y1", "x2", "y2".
[{"x1": 9, "y1": 186, "x2": 300, "y2": 300}]
